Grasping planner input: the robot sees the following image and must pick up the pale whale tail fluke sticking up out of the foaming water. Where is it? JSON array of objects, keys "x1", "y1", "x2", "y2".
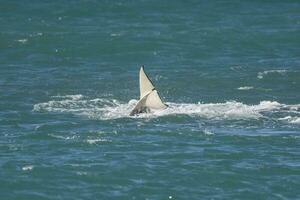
[{"x1": 130, "y1": 66, "x2": 168, "y2": 115}]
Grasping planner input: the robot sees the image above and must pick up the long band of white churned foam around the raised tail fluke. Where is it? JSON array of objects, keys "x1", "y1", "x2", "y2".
[{"x1": 33, "y1": 95, "x2": 300, "y2": 124}]
